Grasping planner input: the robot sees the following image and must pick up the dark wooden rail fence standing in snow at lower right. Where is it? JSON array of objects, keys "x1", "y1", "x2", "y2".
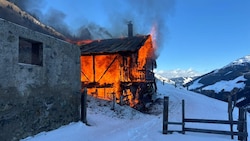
[{"x1": 163, "y1": 97, "x2": 248, "y2": 141}]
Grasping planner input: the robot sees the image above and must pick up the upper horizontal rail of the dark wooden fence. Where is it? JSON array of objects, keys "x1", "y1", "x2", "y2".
[{"x1": 184, "y1": 118, "x2": 242, "y2": 124}]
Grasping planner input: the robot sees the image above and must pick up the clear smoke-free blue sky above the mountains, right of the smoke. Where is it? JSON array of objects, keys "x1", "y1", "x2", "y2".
[{"x1": 158, "y1": 0, "x2": 250, "y2": 73}]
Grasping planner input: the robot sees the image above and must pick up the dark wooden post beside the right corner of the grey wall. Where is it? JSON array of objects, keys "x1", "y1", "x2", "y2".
[{"x1": 81, "y1": 87, "x2": 87, "y2": 124}]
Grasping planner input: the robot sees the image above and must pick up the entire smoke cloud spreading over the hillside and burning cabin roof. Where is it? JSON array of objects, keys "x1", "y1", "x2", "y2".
[{"x1": 6, "y1": 0, "x2": 175, "y2": 54}]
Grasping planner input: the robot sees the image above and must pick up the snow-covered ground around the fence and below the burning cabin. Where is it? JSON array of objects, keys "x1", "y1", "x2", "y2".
[{"x1": 21, "y1": 81, "x2": 250, "y2": 141}]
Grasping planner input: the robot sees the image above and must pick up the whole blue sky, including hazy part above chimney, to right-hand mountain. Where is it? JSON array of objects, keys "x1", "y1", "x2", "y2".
[{"x1": 38, "y1": 0, "x2": 250, "y2": 74}]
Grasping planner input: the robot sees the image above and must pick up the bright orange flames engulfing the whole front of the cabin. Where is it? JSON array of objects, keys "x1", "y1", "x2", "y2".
[{"x1": 81, "y1": 35, "x2": 155, "y2": 107}]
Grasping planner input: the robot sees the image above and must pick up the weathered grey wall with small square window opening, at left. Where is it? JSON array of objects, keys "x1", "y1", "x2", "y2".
[{"x1": 0, "y1": 19, "x2": 81, "y2": 141}]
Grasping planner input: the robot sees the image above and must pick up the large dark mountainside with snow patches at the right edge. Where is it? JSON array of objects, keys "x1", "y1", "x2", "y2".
[{"x1": 186, "y1": 55, "x2": 250, "y2": 106}]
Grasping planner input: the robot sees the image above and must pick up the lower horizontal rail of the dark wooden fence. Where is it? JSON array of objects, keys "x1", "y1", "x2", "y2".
[{"x1": 184, "y1": 128, "x2": 247, "y2": 136}]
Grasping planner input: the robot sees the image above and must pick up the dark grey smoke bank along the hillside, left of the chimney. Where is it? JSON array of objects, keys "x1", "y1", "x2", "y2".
[{"x1": 8, "y1": 0, "x2": 93, "y2": 40}]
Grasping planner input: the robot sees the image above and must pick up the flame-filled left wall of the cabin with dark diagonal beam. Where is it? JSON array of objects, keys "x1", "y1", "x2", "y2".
[{"x1": 81, "y1": 54, "x2": 121, "y2": 100}]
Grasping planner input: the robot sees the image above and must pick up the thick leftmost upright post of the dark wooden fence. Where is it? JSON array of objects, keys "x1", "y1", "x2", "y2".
[{"x1": 162, "y1": 96, "x2": 169, "y2": 134}]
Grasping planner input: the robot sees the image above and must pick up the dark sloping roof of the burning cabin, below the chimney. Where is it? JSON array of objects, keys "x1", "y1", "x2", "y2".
[{"x1": 80, "y1": 35, "x2": 150, "y2": 55}]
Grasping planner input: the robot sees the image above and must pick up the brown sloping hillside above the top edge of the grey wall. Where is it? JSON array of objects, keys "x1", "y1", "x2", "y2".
[{"x1": 0, "y1": 0, "x2": 66, "y2": 40}]
